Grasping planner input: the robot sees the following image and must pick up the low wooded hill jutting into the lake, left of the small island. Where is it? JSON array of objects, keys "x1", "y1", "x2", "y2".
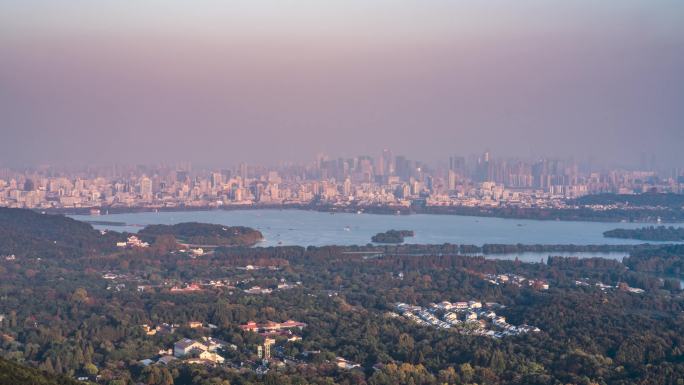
[{"x1": 138, "y1": 222, "x2": 263, "y2": 246}]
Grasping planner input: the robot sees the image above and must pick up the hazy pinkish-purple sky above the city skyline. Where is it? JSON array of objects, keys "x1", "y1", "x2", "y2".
[{"x1": 0, "y1": 0, "x2": 684, "y2": 166}]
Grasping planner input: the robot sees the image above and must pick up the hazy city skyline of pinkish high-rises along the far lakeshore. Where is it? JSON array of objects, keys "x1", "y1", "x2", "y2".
[{"x1": 0, "y1": 150, "x2": 684, "y2": 213}]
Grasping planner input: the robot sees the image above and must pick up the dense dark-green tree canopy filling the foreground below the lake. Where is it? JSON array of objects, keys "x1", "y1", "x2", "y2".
[{"x1": 0, "y1": 208, "x2": 684, "y2": 385}]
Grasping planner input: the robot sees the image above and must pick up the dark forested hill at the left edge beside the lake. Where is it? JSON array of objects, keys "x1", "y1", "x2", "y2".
[{"x1": 0, "y1": 208, "x2": 123, "y2": 258}]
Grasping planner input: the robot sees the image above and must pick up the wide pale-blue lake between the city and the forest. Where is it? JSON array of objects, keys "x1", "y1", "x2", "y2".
[{"x1": 71, "y1": 209, "x2": 680, "y2": 252}]
